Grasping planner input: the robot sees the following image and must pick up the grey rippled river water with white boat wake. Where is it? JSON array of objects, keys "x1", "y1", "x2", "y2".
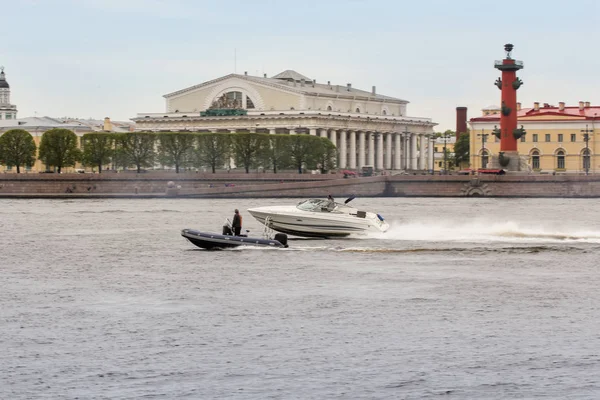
[{"x1": 0, "y1": 198, "x2": 600, "y2": 399}]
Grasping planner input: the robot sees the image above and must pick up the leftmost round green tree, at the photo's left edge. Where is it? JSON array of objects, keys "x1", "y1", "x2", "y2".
[{"x1": 0, "y1": 129, "x2": 36, "y2": 174}]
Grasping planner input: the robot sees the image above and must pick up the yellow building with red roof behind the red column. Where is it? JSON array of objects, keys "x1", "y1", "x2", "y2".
[{"x1": 470, "y1": 101, "x2": 600, "y2": 173}]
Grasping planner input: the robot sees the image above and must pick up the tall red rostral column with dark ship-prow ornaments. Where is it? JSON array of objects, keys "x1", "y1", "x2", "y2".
[{"x1": 494, "y1": 43, "x2": 524, "y2": 152}]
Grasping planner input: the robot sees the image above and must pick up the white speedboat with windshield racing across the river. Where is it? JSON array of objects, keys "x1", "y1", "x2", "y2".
[{"x1": 248, "y1": 197, "x2": 389, "y2": 238}]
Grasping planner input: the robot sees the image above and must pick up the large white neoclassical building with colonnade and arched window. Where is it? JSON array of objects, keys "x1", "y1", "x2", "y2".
[{"x1": 132, "y1": 70, "x2": 437, "y2": 170}]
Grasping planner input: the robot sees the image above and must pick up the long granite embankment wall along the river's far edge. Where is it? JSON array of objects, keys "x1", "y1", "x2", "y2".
[{"x1": 0, "y1": 173, "x2": 600, "y2": 198}]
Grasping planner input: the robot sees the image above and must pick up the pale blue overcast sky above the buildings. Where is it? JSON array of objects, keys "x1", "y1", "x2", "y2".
[{"x1": 0, "y1": 0, "x2": 600, "y2": 131}]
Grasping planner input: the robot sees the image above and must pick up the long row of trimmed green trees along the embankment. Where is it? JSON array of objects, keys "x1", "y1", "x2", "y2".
[{"x1": 0, "y1": 129, "x2": 337, "y2": 173}]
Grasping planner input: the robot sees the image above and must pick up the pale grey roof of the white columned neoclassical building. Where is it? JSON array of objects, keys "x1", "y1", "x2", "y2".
[{"x1": 163, "y1": 70, "x2": 408, "y2": 104}]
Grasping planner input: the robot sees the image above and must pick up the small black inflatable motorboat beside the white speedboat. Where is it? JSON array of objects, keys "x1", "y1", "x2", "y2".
[{"x1": 181, "y1": 220, "x2": 288, "y2": 250}]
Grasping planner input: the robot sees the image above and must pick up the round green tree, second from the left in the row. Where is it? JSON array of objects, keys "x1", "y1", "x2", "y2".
[{"x1": 39, "y1": 128, "x2": 82, "y2": 174}]
